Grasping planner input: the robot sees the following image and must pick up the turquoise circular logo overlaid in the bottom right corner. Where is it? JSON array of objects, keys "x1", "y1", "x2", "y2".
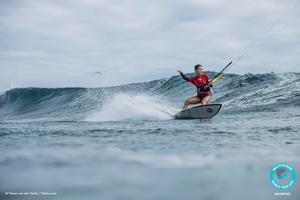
[{"x1": 270, "y1": 163, "x2": 296, "y2": 189}]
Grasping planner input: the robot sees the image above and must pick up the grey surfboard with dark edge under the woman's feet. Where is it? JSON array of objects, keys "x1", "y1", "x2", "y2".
[{"x1": 173, "y1": 104, "x2": 222, "y2": 119}]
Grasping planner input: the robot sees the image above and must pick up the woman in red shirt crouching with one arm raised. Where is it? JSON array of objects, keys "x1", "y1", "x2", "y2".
[{"x1": 178, "y1": 64, "x2": 212, "y2": 109}]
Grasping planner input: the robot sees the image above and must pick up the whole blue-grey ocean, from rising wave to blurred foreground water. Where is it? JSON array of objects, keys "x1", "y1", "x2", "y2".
[{"x1": 0, "y1": 72, "x2": 300, "y2": 200}]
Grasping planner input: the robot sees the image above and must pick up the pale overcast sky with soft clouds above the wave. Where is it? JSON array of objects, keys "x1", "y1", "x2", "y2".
[{"x1": 0, "y1": 0, "x2": 300, "y2": 91}]
